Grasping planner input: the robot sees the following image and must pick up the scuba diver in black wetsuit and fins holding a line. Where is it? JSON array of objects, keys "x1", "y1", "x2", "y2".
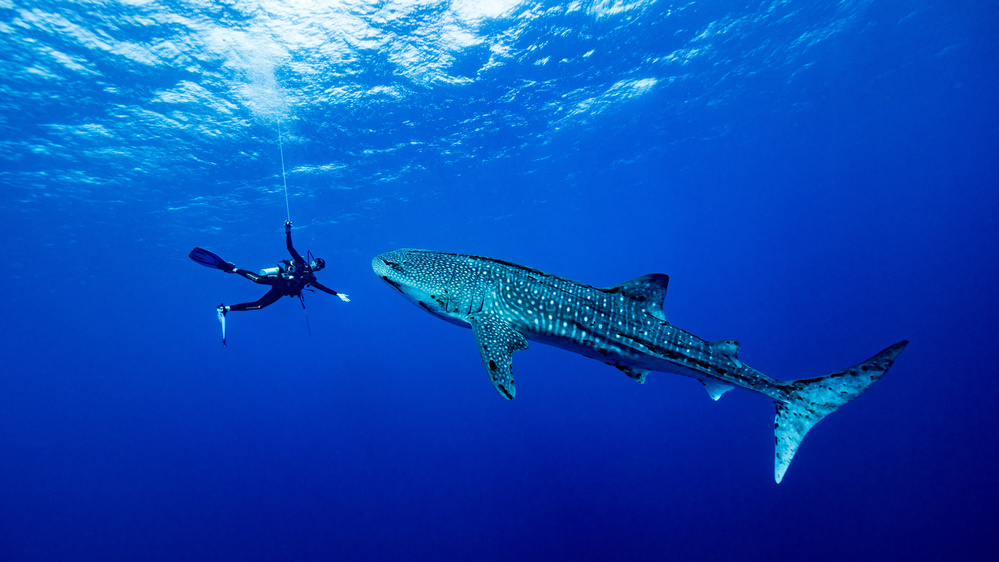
[{"x1": 189, "y1": 221, "x2": 350, "y2": 345}]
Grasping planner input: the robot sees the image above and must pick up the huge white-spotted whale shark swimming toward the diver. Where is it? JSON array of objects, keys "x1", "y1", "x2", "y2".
[{"x1": 371, "y1": 249, "x2": 909, "y2": 483}]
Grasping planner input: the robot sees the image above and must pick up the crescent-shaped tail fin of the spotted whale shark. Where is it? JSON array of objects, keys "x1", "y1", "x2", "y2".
[{"x1": 774, "y1": 341, "x2": 909, "y2": 484}]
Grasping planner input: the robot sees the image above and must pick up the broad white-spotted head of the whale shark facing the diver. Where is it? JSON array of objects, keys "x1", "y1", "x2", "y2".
[{"x1": 371, "y1": 248, "x2": 456, "y2": 322}]
